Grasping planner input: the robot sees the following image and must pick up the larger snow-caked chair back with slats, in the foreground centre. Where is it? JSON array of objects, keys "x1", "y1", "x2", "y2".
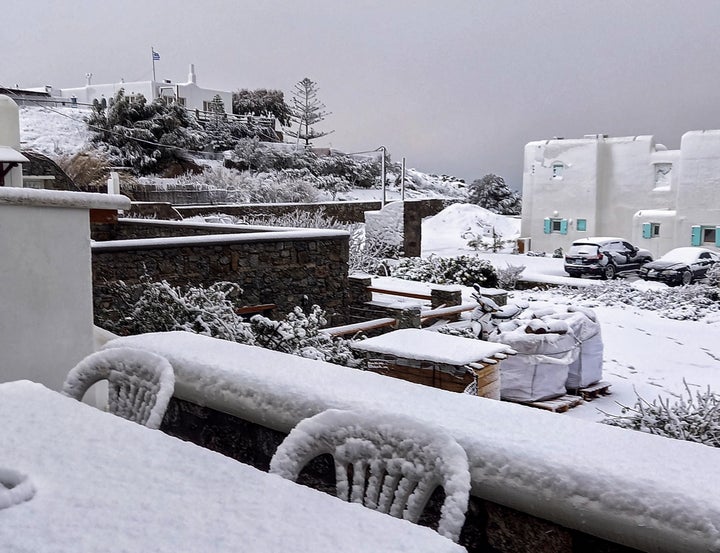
[{"x1": 270, "y1": 409, "x2": 470, "y2": 541}]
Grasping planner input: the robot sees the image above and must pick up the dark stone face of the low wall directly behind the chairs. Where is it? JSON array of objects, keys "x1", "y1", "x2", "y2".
[{"x1": 161, "y1": 397, "x2": 639, "y2": 553}]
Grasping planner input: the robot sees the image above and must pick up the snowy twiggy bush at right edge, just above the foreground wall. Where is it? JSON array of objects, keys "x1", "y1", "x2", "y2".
[{"x1": 602, "y1": 383, "x2": 720, "y2": 447}]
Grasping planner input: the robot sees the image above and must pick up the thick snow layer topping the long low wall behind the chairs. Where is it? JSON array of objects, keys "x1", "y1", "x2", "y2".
[{"x1": 106, "y1": 332, "x2": 720, "y2": 553}]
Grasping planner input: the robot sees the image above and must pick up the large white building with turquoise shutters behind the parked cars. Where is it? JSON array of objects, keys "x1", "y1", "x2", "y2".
[{"x1": 521, "y1": 130, "x2": 720, "y2": 257}]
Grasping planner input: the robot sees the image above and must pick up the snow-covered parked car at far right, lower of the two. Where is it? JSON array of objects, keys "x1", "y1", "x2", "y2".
[{"x1": 640, "y1": 247, "x2": 720, "y2": 284}]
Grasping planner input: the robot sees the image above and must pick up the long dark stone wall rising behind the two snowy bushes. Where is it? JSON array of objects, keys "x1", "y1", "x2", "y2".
[{"x1": 92, "y1": 227, "x2": 349, "y2": 325}]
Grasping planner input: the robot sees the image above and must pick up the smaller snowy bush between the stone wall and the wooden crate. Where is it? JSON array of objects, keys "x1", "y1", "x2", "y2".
[{"x1": 250, "y1": 305, "x2": 360, "y2": 367}]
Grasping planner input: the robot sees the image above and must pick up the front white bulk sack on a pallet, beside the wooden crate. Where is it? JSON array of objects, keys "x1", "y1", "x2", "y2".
[{"x1": 490, "y1": 326, "x2": 580, "y2": 402}]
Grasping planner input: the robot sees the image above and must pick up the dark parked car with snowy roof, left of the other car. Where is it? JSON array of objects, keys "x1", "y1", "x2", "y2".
[{"x1": 565, "y1": 236, "x2": 652, "y2": 279}]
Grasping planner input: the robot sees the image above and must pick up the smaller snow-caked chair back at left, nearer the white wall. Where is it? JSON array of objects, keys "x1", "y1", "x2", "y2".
[{"x1": 62, "y1": 348, "x2": 175, "y2": 428}]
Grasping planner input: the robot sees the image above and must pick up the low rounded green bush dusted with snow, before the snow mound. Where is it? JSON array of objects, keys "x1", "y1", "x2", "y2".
[{"x1": 392, "y1": 255, "x2": 497, "y2": 288}]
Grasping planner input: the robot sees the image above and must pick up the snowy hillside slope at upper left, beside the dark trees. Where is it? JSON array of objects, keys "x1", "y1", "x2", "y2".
[{"x1": 20, "y1": 106, "x2": 90, "y2": 159}]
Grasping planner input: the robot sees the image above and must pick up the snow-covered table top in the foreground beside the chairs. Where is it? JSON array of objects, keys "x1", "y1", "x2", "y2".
[{"x1": 0, "y1": 381, "x2": 465, "y2": 553}]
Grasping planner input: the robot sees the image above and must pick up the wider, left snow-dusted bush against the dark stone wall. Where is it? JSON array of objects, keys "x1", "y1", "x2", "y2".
[{"x1": 101, "y1": 277, "x2": 255, "y2": 344}]
